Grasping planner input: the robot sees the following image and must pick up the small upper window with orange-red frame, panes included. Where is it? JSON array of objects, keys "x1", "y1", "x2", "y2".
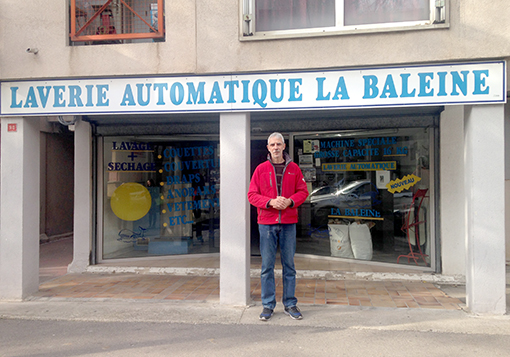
[{"x1": 70, "y1": 0, "x2": 165, "y2": 45}]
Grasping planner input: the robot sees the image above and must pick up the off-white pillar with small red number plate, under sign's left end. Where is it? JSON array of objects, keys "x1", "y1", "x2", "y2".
[{"x1": 0, "y1": 117, "x2": 40, "y2": 300}]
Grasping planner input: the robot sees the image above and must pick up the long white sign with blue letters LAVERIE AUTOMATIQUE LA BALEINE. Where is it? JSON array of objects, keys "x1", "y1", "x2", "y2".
[{"x1": 0, "y1": 61, "x2": 506, "y2": 115}]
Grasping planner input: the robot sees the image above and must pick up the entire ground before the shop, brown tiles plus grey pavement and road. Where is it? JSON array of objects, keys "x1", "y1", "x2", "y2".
[{"x1": 0, "y1": 234, "x2": 510, "y2": 356}]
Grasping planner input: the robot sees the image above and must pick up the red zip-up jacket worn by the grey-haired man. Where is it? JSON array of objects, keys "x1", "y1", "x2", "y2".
[{"x1": 248, "y1": 153, "x2": 308, "y2": 224}]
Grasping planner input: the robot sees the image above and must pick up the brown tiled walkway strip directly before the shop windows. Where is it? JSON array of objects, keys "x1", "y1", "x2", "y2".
[{"x1": 34, "y1": 239, "x2": 465, "y2": 310}]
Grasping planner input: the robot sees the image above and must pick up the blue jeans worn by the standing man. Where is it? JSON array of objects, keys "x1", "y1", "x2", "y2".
[{"x1": 259, "y1": 224, "x2": 297, "y2": 309}]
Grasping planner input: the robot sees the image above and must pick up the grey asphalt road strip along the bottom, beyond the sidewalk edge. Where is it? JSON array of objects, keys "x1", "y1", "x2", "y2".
[{"x1": 0, "y1": 319, "x2": 510, "y2": 357}]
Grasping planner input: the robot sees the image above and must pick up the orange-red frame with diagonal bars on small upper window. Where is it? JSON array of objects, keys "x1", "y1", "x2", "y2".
[{"x1": 69, "y1": 0, "x2": 165, "y2": 44}]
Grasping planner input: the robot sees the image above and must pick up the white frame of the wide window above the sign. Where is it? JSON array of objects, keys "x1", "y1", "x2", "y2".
[{"x1": 239, "y1": 0, "x2": 450, "y2": 41}]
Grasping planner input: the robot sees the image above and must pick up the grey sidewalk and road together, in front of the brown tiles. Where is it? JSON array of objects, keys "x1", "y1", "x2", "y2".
[{"x1": 0, "y1": 300, "x2": 510, "y2": 357}]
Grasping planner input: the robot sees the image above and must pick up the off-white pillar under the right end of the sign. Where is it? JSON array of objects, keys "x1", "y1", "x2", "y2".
[{"x1": 466, "y1": 105, "x2": 506, "y2": 314}]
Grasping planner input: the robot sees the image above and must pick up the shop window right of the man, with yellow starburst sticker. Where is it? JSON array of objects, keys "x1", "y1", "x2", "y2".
[{"x1": 293, "y1": 128, "x2": 434, "y2": 267}]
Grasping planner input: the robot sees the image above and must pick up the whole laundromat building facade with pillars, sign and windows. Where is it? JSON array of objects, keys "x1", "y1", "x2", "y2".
[{"x1": 0, "y1": 0, "x2": 510, "y2": 314}]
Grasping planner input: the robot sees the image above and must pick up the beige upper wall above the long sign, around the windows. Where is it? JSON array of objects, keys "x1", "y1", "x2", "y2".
[{"x1": 0, "y1": 0, "x2": 510, "y2": 79}]
